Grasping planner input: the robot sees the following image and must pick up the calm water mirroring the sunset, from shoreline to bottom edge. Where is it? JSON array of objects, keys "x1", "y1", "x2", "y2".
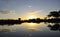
[{"x1": 0, "y1": 23, "x2": 60, "y2": 37}]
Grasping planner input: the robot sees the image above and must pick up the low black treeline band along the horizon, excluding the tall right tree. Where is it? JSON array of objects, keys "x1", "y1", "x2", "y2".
[{"x1": 0, "y1": 18, "x2": 60, "y2": 24}]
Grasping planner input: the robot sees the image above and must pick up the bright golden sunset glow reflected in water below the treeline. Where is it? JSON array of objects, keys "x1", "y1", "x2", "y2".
[{"x1": 21, "y1": 23, "x2": 46, "y2": 31}]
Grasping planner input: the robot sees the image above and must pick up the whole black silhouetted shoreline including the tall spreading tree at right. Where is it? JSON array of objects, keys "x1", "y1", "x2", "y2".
[{"x1": 0, "y1": 11, "x2": 60, "y2": 25}]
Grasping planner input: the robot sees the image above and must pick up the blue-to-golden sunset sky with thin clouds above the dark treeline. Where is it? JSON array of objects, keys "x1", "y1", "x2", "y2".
[{"x1": 0, "y1": 0, "x2": 60, "y2": 19}]
